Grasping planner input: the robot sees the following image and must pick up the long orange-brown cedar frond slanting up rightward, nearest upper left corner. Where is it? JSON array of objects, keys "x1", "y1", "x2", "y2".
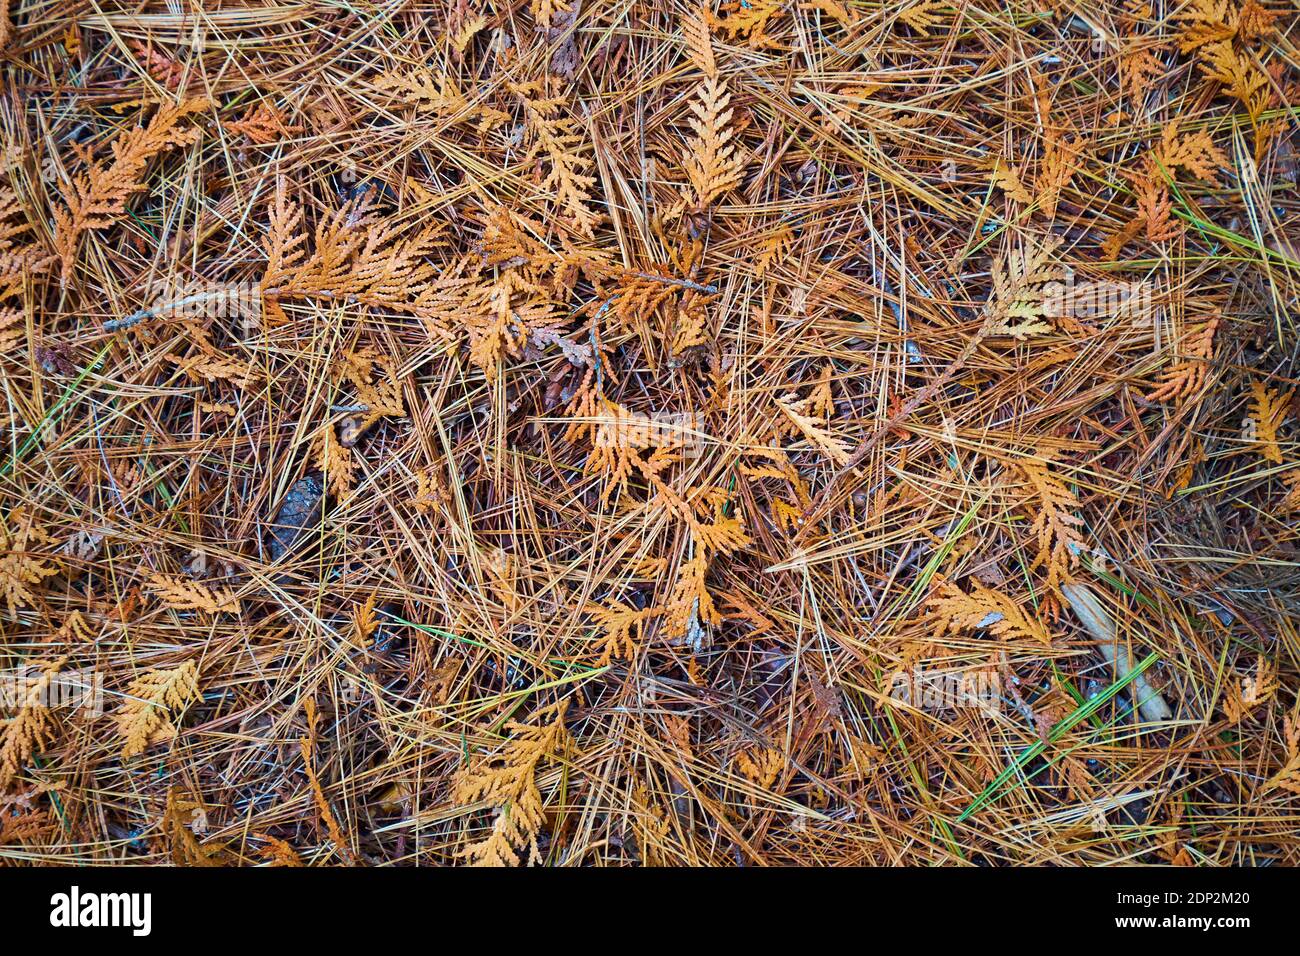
[{"x1": 55, "y1": 98, "x2": 209, "y2": 281}]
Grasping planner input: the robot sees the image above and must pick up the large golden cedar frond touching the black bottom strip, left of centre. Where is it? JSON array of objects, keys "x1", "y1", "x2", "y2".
[{"x1": 452, "y1": 701, "x2": 568, "y2": 866}]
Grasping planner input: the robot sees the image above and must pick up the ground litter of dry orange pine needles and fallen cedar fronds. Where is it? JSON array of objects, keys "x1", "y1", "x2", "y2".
[{"x1": 0, "y1": 0, "x2": 1300, "y2": 866}]
